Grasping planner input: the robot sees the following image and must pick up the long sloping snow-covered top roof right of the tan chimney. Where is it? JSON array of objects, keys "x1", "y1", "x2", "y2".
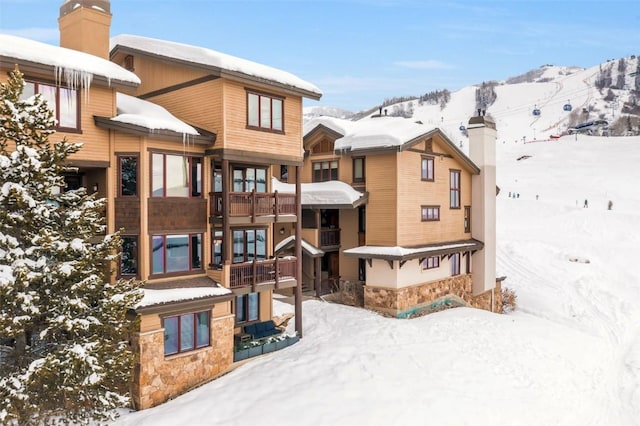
[{"x1": 111, "y1": 34, "x2": 322, "y2": 99}]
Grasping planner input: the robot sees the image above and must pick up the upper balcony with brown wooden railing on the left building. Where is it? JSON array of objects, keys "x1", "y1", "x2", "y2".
[{"x1": 210, "y1": 191, "x2": 296, "y2": 223}]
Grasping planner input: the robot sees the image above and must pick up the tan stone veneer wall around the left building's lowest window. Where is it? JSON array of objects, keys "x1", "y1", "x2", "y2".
[{"x1": 131, "y1": 316, "x2": 234, "y2": 410}]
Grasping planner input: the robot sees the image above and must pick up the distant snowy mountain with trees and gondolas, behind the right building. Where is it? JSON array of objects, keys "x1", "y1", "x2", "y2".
[{"x1": 305, "y1": 55, "x2": 640, "y2": 141}]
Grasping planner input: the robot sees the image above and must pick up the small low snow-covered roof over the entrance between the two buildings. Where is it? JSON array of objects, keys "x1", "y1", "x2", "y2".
[{"x1": 271, "y1": 178, "x2": 368, "y2": 208}]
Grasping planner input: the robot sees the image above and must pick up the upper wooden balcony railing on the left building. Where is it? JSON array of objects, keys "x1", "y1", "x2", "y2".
[{"x1": 210, "y1": 191, "x2": 296, "y2": 217}]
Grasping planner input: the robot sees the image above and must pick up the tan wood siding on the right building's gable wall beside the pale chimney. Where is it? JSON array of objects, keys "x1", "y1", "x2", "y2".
[{"x1": 398, "y1": 139, "x2": 471, "y2": 246}]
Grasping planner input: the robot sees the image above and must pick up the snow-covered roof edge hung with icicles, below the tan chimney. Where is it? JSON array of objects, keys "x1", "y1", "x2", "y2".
[{"x1": 0, "y1": 34, "x2": 140, "y2": 88}]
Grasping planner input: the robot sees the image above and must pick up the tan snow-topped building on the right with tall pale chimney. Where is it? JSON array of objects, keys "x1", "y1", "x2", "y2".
[{"x1": 296, "y1": 116, "x2": 501, "y2": 317}]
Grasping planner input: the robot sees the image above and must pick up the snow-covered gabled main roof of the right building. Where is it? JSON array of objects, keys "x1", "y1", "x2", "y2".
[{"x1": 303, "y1": 116, "x2": 480, "y2": 174}]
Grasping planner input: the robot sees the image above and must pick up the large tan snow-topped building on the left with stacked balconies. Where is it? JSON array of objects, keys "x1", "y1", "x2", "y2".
[{"x1": 0, "y1": 0, "x2": 322, "y2": 409}]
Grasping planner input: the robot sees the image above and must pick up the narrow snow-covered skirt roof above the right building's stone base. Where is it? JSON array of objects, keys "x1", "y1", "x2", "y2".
[{"x1": 344, "y1": 239, "x2": 484, "y2": 260}]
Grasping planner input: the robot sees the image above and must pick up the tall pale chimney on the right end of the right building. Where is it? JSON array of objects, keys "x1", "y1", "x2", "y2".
[{"x1": 467, "y1": 114, "x2": 497, "y2": 295}]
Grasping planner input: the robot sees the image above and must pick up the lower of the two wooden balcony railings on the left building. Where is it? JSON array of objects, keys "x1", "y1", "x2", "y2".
[{"x1": 229, "y1": 257, "x2": 296, "y2": 288}]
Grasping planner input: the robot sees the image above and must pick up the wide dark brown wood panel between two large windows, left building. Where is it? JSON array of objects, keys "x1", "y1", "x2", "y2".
[{"x1": 148, "y1": 198, "x2": 207, "y2": 233}]
